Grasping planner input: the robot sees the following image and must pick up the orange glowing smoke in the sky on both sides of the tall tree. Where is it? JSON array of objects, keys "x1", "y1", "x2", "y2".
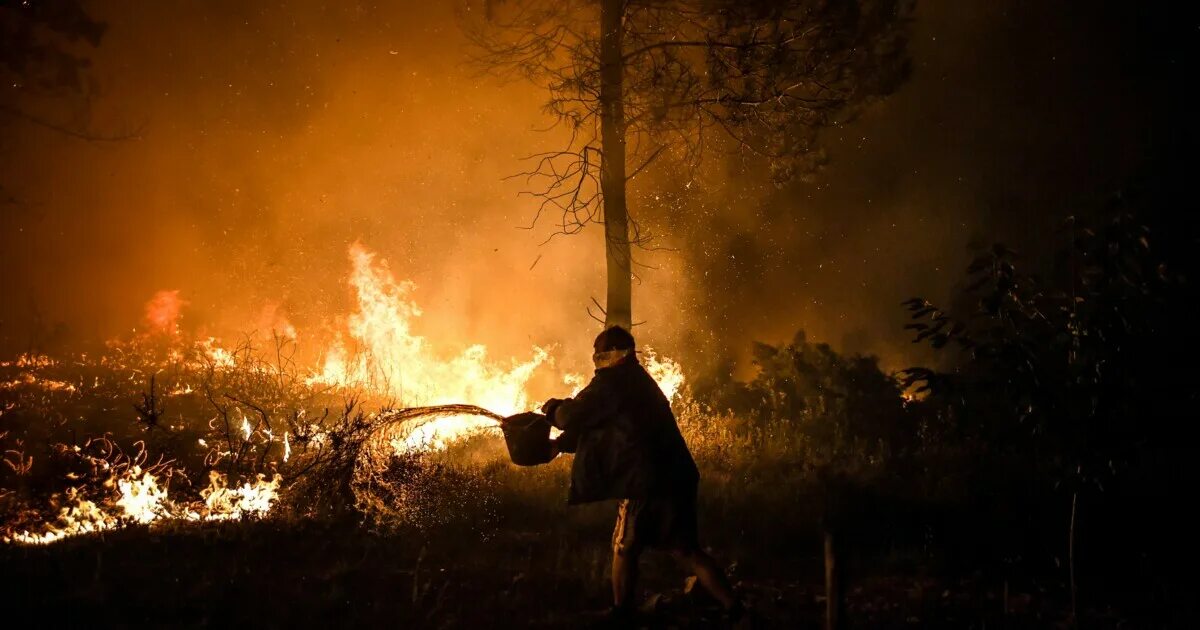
[{"x1": 0, "y1": 0, "x2": 1180, "y2": 379}]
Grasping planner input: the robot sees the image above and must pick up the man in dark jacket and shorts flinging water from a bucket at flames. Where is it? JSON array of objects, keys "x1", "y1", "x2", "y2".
[{"x1": 542, "y1": 326, "x2": 743, "y2": 619}]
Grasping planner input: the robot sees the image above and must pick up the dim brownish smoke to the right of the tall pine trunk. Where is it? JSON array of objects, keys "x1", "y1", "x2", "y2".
[{"x1": 659, "y1": 0, "x2": 1180, "y2": 376}]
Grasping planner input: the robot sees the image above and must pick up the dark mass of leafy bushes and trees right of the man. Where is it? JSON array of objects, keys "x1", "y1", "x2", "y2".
[{"x1": 696, "y1": 152, "x2": 1200, "y2": 624}]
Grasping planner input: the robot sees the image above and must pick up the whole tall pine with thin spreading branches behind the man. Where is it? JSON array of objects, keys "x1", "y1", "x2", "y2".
[{"x1": 462, "y1": 0, "x2": 911, "y2": 328}]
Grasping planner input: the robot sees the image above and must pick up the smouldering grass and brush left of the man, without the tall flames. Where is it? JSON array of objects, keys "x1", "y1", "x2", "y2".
[{"x1": 0, "y1": 326, "x2": 680, "y2": 544}]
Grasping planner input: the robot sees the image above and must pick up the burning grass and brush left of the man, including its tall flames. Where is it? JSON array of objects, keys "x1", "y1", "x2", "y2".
[{"x1": 0, "y1": 244, "x2": 683, "y2": 542}]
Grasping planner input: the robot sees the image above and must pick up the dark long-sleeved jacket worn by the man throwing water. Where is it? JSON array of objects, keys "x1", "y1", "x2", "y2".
[{"x1": 553, "y1": 358, "x2": 700, "y2": 504}]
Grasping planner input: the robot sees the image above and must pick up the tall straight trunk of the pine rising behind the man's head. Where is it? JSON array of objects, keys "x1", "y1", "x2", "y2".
[{"x1": 600, "y1": 0, "x2": 634, "y2": 330}]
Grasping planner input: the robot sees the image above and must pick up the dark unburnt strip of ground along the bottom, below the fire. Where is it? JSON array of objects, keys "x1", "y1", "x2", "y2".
[{"x1": 0, "y1": 513, "x2": 1123, "y2": 629}]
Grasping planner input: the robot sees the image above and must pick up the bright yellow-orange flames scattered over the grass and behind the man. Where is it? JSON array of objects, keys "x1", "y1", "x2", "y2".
[{"x1": 0, "y1": 244, "x2": 684, "y2": 544}]
